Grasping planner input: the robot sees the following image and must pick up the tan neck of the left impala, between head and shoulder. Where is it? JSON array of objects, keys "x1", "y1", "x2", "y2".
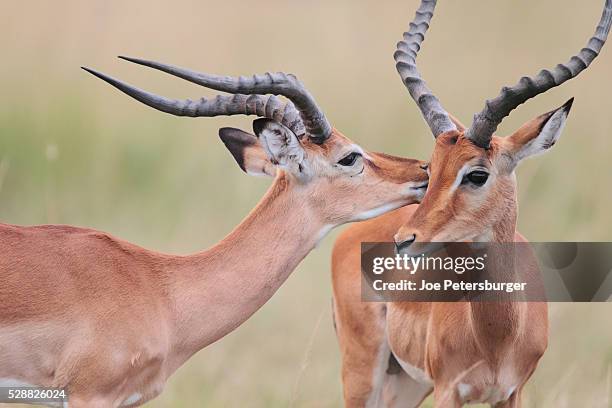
[{"x1": 171, "y1": 174, "x2": 330, "y2": 364}]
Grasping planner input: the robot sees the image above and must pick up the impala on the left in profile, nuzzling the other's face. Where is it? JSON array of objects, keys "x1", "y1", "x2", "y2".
[{"x1": 0, "y1": 58, "x2": 428, "y2": 408}]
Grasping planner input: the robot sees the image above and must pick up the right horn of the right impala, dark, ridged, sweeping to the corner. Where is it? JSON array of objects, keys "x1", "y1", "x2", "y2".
[{"x1": 465, "y1": 0, "x2": 612, "y2": 149}]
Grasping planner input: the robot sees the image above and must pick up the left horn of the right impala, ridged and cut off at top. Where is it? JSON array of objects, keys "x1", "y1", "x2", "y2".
[{"x1": 393, "y1": 0, "x2": 457, "y2": 137}]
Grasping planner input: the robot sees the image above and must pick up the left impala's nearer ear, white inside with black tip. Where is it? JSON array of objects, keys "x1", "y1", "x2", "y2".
[{"x1": 253, "y1": 118, "x2": 304, "y2": 171}]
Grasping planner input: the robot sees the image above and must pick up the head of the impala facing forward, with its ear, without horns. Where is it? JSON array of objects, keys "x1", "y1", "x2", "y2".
[{"x1": 395, "y1": 100, "x2": 573, "y2": 251}]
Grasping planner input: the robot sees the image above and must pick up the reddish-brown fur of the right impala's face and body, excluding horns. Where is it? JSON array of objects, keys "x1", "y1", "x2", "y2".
[{"x1": 332, "y1": 107, "x2": 564, "y2": 408}]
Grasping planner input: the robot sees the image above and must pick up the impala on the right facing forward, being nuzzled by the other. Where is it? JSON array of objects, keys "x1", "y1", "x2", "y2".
[{"x1": 332, "y1": 0, "x2": 612, "y2": 407}]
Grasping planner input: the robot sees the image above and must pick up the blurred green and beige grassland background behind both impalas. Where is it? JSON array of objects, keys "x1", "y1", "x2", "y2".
[{"x1": 0, "y1": 0, "x2": 612, "y2": 407}]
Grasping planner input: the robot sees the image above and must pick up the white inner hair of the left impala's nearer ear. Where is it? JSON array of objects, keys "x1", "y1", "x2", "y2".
[{"x1": 259, "y1": 122, "x2": 304, "y2": 166}]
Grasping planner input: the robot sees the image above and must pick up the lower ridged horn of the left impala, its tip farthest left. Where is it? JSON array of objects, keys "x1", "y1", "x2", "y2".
[{"x1": 81, "y1": 67, "x2": 305, "y2": 135}]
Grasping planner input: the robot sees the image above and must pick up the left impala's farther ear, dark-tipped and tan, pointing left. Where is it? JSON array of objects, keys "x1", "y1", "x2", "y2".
[{"x1": 219, "y1": 128, "x2": 276, "y2": 177}]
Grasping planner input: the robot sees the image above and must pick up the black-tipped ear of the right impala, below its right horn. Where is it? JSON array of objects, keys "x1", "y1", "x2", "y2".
[{"x1": 504, "y1": 98, "x2": 574, "y2": 165}]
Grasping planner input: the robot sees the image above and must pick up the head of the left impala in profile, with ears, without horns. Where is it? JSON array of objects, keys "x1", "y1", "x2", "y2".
[{"x1": 219, "y1": 119, "x2": 428, "y2": 225}]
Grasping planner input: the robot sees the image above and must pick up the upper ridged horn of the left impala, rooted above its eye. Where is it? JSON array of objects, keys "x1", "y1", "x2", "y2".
[{"x1": 119, "y1": 56, "x2": 332, "y2": 144}]
